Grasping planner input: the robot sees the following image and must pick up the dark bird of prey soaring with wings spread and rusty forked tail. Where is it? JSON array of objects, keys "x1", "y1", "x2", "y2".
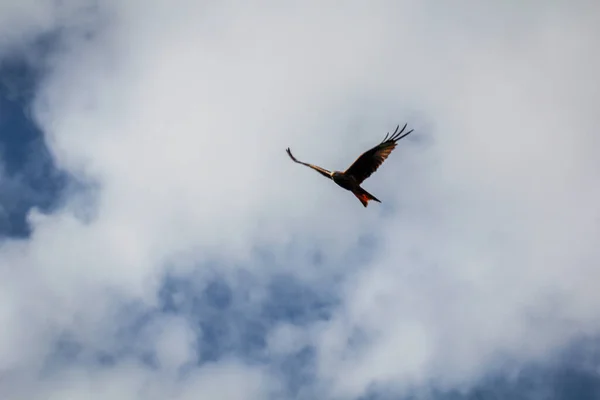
[{"x1": 286, "y1": 124, "x2": 413, "y2": 207}]
